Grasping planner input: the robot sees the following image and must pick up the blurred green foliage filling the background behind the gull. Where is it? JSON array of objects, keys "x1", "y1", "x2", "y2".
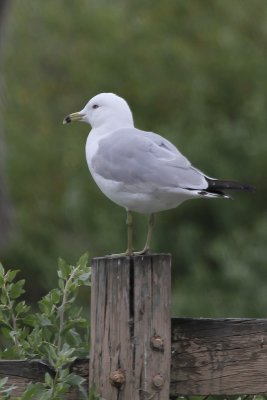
[{"x1": 2, "y1": 0, "x2": 267, "y2": 317}]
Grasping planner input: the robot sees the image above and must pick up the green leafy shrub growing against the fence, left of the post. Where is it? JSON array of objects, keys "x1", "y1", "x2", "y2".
[{"x1": 0, "y1": 254, "x2": 91, "y2": 400}]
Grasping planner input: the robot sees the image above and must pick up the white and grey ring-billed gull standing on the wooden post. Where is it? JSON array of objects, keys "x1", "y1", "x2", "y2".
[{"x1": 63, "y1": 93, "x2": 253, "y2": 255}]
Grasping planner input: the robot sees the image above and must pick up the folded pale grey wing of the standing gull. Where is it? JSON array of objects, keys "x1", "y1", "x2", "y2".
[{"x1": 92, "y1": 128, "x2": 208, "y2": 190}]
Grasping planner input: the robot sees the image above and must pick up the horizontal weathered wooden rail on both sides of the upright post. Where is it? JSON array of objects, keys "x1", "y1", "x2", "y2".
[{"x1": 0, "y1": 318, "x2": 267, "y2": 400}]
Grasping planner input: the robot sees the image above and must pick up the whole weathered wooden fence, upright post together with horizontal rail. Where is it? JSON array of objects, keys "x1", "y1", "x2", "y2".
[{"x1": 0, "y1": 255, "x2": 267, "y2": 400}]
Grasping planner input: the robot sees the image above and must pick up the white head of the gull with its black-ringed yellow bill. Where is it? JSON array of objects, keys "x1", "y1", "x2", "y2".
[{"x1": 63, "y1": 93, "x2": 133, "y2": 128}]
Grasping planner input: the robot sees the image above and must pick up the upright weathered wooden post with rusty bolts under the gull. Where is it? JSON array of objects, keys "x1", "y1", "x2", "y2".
[{"x1": 89, "y1": 254, "x2": 171, "y2": 400}]
